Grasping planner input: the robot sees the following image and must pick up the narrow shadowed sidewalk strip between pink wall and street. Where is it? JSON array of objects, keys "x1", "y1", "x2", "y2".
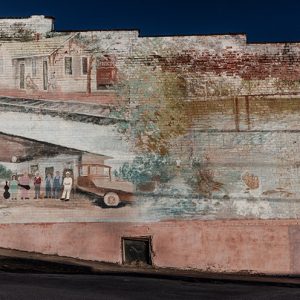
[{"x1": 0, "y1": 248, "x2": 300, "y2": 287}]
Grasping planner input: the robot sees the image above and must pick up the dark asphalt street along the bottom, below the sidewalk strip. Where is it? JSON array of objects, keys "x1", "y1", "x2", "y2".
[{"x1": 0, "y1": 272, "x2": 300, "y2": 300}]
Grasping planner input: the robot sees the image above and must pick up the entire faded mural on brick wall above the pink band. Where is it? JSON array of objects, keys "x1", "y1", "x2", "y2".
[{"x1": 0, "y1": 16, "x2": 300, "y2": 223}]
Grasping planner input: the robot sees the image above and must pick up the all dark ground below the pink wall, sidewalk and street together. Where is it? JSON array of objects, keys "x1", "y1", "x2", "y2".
[{"x1": 0, "y1": 248, "x2": 300, "y2": 300}]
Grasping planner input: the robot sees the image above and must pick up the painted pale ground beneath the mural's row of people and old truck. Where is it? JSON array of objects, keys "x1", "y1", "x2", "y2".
[{"x1": 0, "y1": 194, "x2": 142, "y2": 224}]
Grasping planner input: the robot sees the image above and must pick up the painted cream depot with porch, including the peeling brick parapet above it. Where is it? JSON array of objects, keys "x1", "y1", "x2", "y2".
[{"x1": 0, "y1": 16, "x2": 137, "y2": 103}]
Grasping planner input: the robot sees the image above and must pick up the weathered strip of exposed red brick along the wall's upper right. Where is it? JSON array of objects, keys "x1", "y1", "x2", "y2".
[{"x1": 134, "y1": 35, "x2": 300, "y2": 99}]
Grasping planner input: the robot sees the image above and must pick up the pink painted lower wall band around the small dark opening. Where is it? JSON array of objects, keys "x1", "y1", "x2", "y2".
[{"x1": 0, "y1": 220, "x2": 300, "y2": 274}]
